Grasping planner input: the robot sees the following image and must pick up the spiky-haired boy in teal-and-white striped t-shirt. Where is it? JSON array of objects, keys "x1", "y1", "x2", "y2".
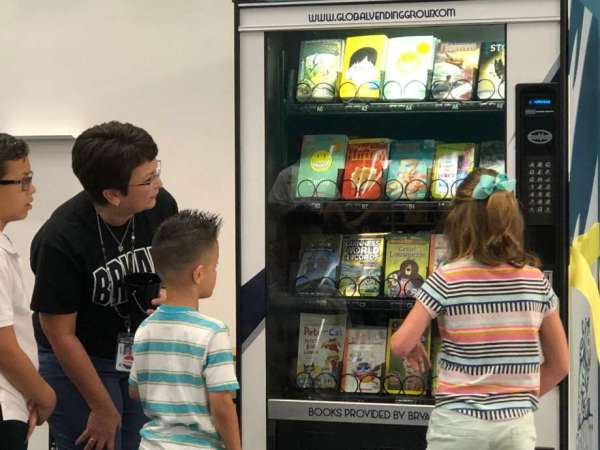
[{"x1": 129, "y1": 210, "x2": 241, "y2": 450}]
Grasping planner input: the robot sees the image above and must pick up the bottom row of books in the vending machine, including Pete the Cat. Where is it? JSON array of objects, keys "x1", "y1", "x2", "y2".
[{"x1": 296, "y1": 313, "x2": 441, "y2": 395}]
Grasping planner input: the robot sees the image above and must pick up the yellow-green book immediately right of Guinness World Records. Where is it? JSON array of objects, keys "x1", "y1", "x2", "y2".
[{"x1": 384, "y1": 234, "x2": 429, "y2": 298}]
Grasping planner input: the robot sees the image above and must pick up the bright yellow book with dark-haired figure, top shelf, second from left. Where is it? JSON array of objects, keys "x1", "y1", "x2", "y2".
[{"x1": 340, "y1": 34, "x2": 388, "y2": 100}]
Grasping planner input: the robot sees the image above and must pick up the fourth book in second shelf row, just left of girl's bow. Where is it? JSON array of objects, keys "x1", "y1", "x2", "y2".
[{"x1": 431, "y1": 142, "x2": 475, "y2": 199}]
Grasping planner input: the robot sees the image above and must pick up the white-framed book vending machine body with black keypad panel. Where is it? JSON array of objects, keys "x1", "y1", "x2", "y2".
[{"x1": 234, "y1": 0, "x2": 569, "y2": 450}]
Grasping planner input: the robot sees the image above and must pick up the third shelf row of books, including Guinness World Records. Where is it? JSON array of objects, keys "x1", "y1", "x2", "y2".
[{"x1": 296, "y1": 233, "x2": 448, "y2": 298}]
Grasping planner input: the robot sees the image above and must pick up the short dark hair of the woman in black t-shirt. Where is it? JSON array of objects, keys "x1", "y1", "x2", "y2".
[{"x1": 72, "y1": 121, "x2": 158, "y2": 205}]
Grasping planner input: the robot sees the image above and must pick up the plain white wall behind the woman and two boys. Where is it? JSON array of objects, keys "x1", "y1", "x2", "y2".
[{"x1": 0, "y1": 0, "x2": 235, "y2": 450}]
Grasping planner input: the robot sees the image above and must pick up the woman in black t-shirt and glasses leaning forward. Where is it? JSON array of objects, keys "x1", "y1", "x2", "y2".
[{"x1": 31, "y1": 122, "x2": 177, "y2": 450}]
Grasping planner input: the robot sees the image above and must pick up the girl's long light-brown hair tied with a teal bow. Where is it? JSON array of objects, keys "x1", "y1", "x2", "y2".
[{"x1": 444, "y1": 169, "x2": 541, "y2": 267}]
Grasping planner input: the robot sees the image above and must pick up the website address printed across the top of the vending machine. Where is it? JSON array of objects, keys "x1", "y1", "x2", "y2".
[{"x1": 308, "y1": 8, "x2": 456, "y2": 23}]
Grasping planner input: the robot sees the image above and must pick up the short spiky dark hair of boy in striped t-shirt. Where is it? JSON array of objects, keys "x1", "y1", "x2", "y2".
[{"x1": 151, "y1": 209, "x2": 222, "y2": 280}]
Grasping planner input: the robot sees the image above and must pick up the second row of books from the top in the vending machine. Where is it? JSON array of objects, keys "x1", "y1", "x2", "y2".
[{"x1": 296, "y1": 134, "x2": 506, "y2": 200}]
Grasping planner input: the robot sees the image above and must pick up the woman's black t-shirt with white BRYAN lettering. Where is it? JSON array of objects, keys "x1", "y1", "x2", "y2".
[{"x1": 31, "y1": 189, "x2": 177, "y2": 359}]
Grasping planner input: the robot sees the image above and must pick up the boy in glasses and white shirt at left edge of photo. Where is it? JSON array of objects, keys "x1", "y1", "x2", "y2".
[{"x1": 0, "y1": 133, "x2": 56, "y2": 450}]
